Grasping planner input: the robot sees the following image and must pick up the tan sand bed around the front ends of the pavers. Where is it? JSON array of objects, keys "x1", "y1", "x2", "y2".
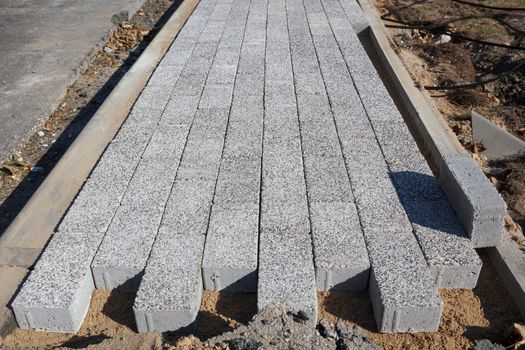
[{"x1": 0, "y1": 251, "x2": 520, "y2": 350}]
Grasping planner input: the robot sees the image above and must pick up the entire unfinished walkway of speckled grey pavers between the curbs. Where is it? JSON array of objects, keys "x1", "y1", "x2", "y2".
[{"x1": 12, "y1": 0, "x2": 488, "y2": 332}]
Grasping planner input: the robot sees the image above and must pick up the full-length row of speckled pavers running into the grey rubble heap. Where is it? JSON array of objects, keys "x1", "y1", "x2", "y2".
[{"x1": 257, "y1": 0, "x2": 317, "y2": 322}]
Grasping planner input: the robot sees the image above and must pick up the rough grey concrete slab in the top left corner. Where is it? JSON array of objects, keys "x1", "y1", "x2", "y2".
[{"x1": 0, "y1": 0, "x2": 143, "y2": 159}]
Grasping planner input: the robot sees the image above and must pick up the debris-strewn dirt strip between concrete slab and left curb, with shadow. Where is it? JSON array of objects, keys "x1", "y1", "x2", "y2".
[{"x1": 0, "y1": 0, "x2": 180, "y2": 235}]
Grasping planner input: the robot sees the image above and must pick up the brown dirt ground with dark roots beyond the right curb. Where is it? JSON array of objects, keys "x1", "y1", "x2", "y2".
[{"x1": 374, "y1": 0, "x2": 525, "y2": 239}]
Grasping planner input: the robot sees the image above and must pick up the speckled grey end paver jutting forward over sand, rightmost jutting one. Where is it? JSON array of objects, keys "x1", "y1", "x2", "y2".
[{"x1": 365, "y1": 231, "x2": 443, "y2": 333}]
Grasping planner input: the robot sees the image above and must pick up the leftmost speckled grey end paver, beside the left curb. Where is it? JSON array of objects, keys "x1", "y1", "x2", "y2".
[{"x1": 11, "y1": 233, "x2": 102, "y2": 333}]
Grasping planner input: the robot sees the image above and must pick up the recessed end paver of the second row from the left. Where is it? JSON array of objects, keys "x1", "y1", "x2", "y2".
[{"x1": 91, "y1": 204, "x2": 163, "y2": 292}]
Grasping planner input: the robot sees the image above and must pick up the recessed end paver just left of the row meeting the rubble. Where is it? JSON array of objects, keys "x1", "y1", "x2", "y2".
[{"x1": 202, "y1": 204, "x2": 259, "y2": 292}]
